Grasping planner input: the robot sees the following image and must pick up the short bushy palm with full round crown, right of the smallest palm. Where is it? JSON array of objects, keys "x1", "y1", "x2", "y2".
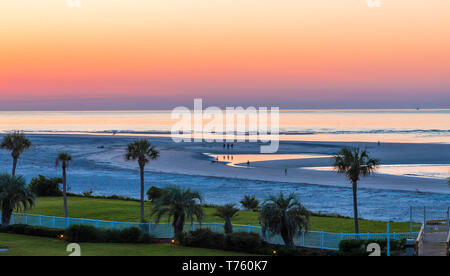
[{"x1": 259, "y1": 193, "x2": 310, "y2": 248}]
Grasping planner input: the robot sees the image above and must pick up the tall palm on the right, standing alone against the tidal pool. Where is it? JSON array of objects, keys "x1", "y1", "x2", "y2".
[{"x1": 333, "y1": 148, "x2": 380, "y2": 234}]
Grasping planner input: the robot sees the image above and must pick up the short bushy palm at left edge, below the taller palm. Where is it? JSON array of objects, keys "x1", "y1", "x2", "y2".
[{"x1": 0, "y1": 174, "x2": 35, "y2": 227}]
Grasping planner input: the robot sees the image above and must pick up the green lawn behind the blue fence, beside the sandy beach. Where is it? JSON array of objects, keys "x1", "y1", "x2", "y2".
[{"x1": 19, "y1": 197, "x2": 417, "y2": 233}]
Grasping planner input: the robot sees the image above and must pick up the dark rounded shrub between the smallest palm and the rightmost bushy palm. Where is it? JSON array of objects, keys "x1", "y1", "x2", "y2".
[{"x1": 225, "y1": 232, "x2": 268, "y2": 253}]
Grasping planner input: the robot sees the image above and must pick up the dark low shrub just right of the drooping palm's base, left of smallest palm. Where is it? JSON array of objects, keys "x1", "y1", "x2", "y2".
[{"x1": 179, "y1": 229, "x2": 225, "y2": 249}]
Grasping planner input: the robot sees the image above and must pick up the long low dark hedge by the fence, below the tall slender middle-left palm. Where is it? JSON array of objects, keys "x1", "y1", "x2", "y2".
[{"x1": 66, "y1": 225, "x2": 153, "y2": 243}]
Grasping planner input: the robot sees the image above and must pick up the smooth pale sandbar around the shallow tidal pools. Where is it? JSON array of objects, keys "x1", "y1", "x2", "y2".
[{"x1": 88, "y1": 137, "x2": 450, "y2": 194}]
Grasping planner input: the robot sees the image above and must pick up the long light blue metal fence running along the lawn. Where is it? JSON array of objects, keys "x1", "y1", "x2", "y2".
[{"x1": 2, "y1": 214, "x2": 418, "y2": 250}]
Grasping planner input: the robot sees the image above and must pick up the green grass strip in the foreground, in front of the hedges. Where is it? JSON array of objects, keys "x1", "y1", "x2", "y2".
[{"x1": 0, "y1": 233, "x2": 253, "y2": 256}]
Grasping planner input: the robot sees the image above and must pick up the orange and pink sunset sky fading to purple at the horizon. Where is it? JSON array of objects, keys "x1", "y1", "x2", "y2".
[{"x1": 0, "y1": 0, "x2": 450, "y2": 110}]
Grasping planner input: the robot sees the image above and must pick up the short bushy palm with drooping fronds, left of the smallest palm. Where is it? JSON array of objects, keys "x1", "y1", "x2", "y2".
[{"x1": 150, "y1": 186, "x2": 204, "y2": 238}]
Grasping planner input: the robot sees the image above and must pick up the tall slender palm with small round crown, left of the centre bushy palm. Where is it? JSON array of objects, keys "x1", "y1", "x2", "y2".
[{"x1": 125, "y1": 139, "x2": 159, "y2": 222}]
